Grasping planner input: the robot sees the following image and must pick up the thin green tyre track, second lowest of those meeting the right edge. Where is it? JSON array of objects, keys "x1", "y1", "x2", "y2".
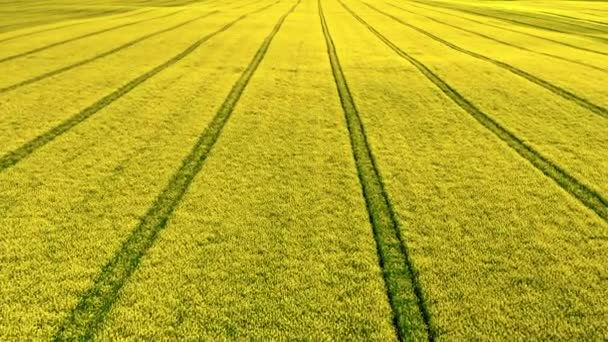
[{"x1": 362, "y1": 1, "x2": 608, "y2": 118}]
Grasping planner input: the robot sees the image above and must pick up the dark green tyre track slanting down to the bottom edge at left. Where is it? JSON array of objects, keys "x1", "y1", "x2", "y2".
[{"x1": 53, "y1": 0, "x2": 300, "y2": 341}]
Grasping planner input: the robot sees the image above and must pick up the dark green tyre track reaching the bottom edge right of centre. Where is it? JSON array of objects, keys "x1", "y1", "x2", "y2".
[{"x1": 318, "y1": 0, "x2": 435, "y2": 341}]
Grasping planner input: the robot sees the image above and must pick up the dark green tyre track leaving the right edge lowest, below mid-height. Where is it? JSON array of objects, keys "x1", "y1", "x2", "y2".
[{"x1": 338, "y1": 0, "x2": 608, "y2": 222}]
